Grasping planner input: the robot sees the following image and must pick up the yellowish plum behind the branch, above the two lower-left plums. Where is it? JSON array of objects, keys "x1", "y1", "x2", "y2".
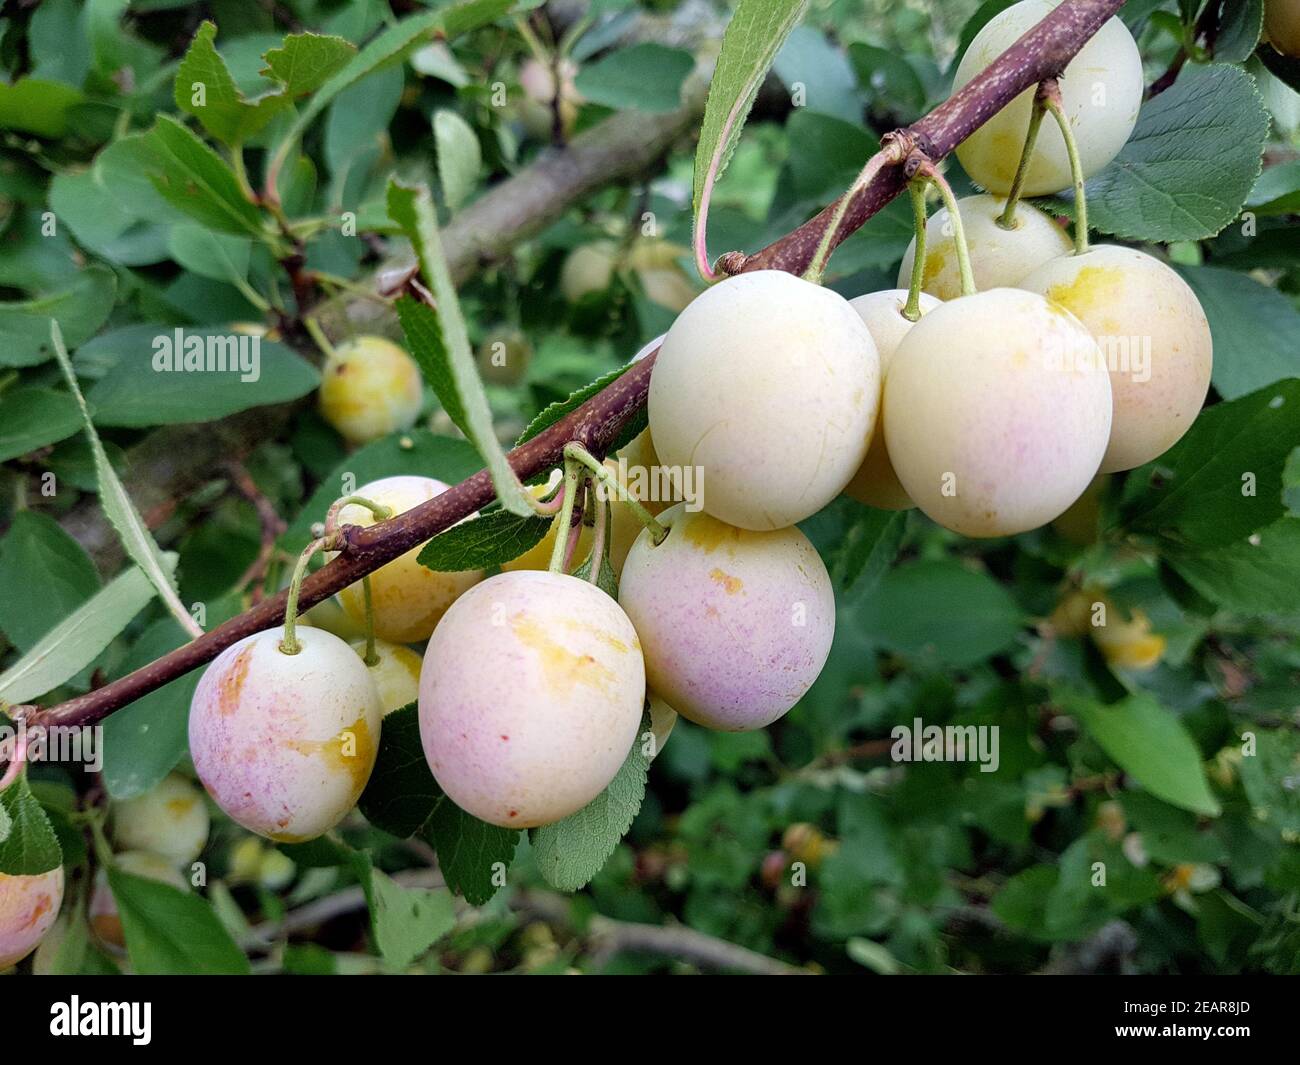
[{"x1": 330, "y1": 475, "x2": 484, "y2": 644}]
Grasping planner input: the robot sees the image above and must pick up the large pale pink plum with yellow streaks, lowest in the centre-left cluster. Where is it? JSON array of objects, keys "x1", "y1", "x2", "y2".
[{"x1": 420, "y1": 570, "x2": 645, "y2": 828}]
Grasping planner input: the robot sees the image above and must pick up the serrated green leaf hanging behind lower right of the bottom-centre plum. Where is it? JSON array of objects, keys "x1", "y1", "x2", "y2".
[{"x1": 528, "y1": 717, "x2": 650, "y2": 891}]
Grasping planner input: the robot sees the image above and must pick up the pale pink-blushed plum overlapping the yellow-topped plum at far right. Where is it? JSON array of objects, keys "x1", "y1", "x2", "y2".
[{"x1": 884, "y1": 289, "x2": 1110, "y2": 536}]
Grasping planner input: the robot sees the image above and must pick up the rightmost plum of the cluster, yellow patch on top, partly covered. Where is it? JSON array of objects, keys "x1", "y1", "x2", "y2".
[{"x1": 1021, "y1": 244, "x2": 1214, "y2": 473}]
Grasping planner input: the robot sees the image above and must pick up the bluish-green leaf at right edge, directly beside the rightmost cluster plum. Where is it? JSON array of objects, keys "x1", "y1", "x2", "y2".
[{"x1": 1178, "y1": 267, "x2": 1300, "y2": 399}]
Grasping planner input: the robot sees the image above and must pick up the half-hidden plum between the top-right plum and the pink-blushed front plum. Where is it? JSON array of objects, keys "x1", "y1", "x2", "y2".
[{"x1": 899, "y1": 195, "x2": 1073, "y2": 300}]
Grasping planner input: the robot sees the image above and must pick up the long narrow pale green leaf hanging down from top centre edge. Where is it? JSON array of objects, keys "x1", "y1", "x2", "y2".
[{"x1": 692, "y1": 0, "x2": 807, "y2": 220}]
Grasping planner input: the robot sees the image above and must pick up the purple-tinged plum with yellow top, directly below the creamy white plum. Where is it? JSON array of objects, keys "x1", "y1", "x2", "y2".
[{"x1": 619, "y1": 503, "x2": 835, "y2": 732}]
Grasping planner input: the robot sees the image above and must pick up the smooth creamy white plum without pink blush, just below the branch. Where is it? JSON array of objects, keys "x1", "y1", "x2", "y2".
[{"x1": 649, "y1": 270, "x2": 880, "y2": 531}]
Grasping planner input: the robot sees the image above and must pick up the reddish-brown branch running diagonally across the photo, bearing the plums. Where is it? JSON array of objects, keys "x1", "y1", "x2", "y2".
[{"x1": 27, "y1": 0, "x2": 1123, "y2": 726}]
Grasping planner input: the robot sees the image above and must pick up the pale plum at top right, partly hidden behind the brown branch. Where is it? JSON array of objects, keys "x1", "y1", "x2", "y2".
[{"x1": 953, "y1": 0, "x2": 1145, "y2": 196}]
